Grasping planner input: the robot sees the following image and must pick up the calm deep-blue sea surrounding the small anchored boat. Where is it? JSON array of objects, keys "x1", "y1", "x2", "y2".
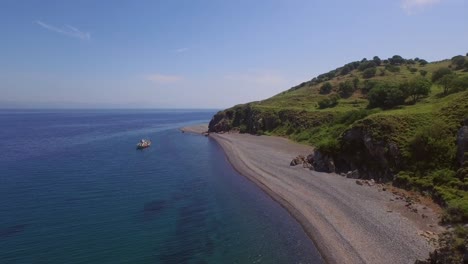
[{"x1": 0, "y1": 110, "x2": 321, "y2": 264}]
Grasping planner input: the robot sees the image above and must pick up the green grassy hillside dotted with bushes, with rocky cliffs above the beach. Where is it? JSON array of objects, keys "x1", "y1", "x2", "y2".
[{"x1": 209, "y1": 54, "x2": 468, "y2": 263}]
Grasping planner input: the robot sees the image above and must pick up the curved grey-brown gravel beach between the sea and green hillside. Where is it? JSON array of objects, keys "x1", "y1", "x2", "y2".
[{"x1": 210, "y1": 133, "x2": 436, "y2": 264}]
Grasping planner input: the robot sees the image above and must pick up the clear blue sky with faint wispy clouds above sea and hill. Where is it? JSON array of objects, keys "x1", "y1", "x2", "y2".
[{"x1": 0, "y1": 0, "x2": 468, "y2": 109}]
